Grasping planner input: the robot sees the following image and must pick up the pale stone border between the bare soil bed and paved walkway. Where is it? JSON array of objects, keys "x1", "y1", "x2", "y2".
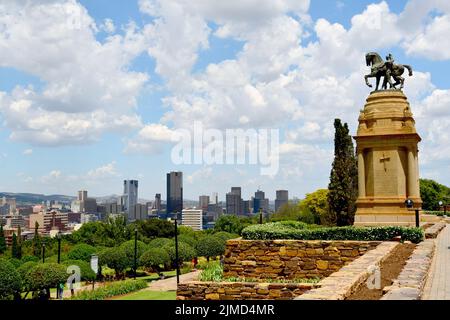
[{"x1": 381, "y1": 239, "x2": 435, "y2": 300}]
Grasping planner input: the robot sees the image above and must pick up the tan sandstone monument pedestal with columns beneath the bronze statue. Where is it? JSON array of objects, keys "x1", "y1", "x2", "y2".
[{"x1": 354, "y1": 90, "x2": 422, "y2": 226}]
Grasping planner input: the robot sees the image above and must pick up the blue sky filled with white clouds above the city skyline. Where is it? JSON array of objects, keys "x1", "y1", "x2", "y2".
[{"x1": 0, "y1": 0, "x2": 450, "y2": 199}]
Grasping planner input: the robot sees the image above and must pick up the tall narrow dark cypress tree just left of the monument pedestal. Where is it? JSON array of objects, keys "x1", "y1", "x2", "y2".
[{"x1": 327, "y1": 119, "x2": 358, "y2": 226}]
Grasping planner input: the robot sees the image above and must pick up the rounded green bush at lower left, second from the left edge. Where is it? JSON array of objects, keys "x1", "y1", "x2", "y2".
[{"x1": 25, "y1": 263, "x2": 69, "y2": 291}]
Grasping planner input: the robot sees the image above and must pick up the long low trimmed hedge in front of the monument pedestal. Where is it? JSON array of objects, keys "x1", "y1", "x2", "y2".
[{"x1": 242, "y1": 223, "x2": 424, "y2": 243}]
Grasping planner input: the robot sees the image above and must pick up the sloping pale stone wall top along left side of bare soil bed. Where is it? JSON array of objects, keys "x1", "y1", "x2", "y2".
[{"x1": 295, "y1": 242, "x2": 399, "y2": 300}]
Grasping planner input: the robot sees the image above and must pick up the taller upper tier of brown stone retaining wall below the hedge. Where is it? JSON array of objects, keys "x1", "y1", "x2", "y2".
[{"x1": 224, "y1": 239, "x2": 381, "y2": 279}]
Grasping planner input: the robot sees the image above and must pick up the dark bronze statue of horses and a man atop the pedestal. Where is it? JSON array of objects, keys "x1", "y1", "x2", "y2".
[{"x1": 364, "y1": 52, "x2": 413, "y2": 91}]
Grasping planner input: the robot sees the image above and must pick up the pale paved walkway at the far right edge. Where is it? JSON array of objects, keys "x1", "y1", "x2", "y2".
[{"x1": 422, "y1": 225, "x2": 450, "y2": 300}]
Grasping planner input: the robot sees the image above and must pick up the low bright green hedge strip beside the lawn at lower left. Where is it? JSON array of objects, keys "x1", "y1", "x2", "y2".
[{"x1": 72, "y1": 280, "x2": 147, "y2": 300}]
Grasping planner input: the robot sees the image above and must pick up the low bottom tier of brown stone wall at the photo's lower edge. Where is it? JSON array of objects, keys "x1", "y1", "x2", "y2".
[{"x1": 177, "y1": 281, "x2": 317, "y2": 300}]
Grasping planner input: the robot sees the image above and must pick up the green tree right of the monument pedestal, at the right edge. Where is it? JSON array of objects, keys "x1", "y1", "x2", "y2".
[{"x1": 420, "y1": 179, "x2": 450, "y2": 210}]
